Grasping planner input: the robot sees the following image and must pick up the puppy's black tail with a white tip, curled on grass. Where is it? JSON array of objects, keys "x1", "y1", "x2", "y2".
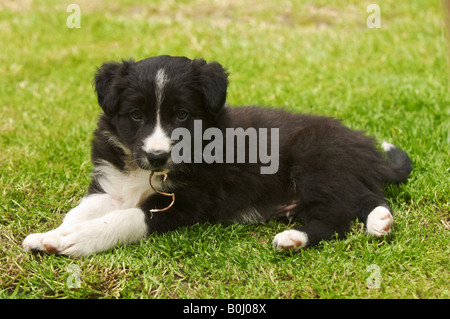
[{"x1": 381, "y1": 142, "x2": 412, "y2": 183}]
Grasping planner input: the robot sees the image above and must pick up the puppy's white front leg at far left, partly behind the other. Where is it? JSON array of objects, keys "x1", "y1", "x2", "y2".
[{"x1": 23, "y1": 194, "x2": 117, "y2": 253}]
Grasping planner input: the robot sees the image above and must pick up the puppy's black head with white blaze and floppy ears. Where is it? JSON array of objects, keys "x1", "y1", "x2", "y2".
[{"x1": 94, "y1": 56, "x2": 228, "y2": 171}]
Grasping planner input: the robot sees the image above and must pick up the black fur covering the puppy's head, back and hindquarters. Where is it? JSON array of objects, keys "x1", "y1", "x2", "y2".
[{"x1": 89, "y1": 56, "x2": 411, "y2": 245}]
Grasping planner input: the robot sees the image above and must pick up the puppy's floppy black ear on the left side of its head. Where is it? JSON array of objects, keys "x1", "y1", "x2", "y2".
[{"x1": 93, "y1": 60, "x2": 133, "y2": 116}]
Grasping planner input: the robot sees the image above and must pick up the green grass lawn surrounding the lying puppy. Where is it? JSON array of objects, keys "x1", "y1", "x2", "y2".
[{"x1": 0, "y1": 0, "x2": 450, "y2": 298}]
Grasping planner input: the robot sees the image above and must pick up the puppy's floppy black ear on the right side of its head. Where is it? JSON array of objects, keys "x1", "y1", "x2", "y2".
[{"x1": 193, "y1": 59, "x2": 228, "y2": 115}]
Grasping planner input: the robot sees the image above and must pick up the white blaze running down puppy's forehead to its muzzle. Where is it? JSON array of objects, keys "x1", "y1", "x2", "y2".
[{"x1": 142, "y1": 69, "x2": 172, "y2": 153}]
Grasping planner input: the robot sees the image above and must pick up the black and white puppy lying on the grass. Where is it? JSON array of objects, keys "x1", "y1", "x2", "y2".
[{"x1": 23, "y1": 56, "x2": 411, "y2": 257}]
